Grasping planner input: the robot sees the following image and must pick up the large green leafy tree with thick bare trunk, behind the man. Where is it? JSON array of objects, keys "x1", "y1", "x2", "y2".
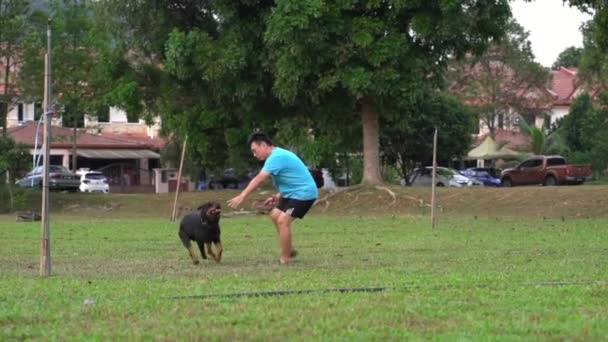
[{"x1": 265, "y1": 0, "x2": 510, "y2": 184}]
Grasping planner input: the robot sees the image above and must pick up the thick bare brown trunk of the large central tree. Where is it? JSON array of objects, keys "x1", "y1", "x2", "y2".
[{"x1": 361, "y1": 97, "x2": 382, "y2": 185}]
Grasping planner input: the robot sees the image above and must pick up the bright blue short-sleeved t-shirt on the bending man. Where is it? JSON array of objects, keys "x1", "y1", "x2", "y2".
[{"x1": 262, "y1": 147, "x2": 319, "y2": 201}]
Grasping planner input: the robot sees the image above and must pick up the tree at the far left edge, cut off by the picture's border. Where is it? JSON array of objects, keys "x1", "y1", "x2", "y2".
[{"x1": 0, "y1": 0, "x2": 30, "y2": 136}]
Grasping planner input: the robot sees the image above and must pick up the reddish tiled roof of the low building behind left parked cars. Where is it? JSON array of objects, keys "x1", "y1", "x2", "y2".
[{"x1": 8, "y1": 122, "x2": 164, "y2": 150}]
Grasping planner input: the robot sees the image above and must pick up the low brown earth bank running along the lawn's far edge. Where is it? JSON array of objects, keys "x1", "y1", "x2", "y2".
[{"x1": 9, "y1": 185, "x2": 608, "y2": 218}]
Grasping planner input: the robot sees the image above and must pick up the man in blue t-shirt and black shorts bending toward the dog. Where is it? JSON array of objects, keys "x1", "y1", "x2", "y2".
[{"x1": 228, "y1": 132, "x2": 319, "y2": 264}]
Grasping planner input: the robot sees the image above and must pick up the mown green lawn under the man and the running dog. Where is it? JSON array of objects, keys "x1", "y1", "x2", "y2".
[{"x1": 0, "y1": 213, "x2": 608, "y2": 341}]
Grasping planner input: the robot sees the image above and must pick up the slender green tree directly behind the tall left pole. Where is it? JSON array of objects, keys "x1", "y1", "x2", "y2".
[{"x1": 22, "y1": 1, "x2": 107, "y2": 170}]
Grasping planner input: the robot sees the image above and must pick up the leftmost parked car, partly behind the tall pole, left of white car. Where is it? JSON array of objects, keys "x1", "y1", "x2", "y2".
[{"x1": 16, "y1": 165, "x2": 80, "y2": 192}]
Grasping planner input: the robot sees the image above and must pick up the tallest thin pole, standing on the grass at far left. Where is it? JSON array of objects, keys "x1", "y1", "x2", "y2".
[{"x1": 40, "y1": 18, "x2": 53, "y2": 277}]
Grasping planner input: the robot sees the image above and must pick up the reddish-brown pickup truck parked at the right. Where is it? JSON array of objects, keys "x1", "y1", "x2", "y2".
[{"x1": 501, "y1": 156, "x2": 592, "y2": 186}]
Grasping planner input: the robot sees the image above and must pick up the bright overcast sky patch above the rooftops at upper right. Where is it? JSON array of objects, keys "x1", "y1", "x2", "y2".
[{"x1": 511, "y1": 0, "x2": 591, "y2": 67}]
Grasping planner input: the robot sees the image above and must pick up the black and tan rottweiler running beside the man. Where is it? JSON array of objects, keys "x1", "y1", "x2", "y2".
[{"x1": 179, "y1": 201, "x2": 223, "y2": 265}]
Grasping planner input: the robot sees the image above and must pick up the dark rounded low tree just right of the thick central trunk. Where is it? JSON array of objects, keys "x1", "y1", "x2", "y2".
[{"x1": 380, "y1": 92, "x2": 475, "y2": 185}]
